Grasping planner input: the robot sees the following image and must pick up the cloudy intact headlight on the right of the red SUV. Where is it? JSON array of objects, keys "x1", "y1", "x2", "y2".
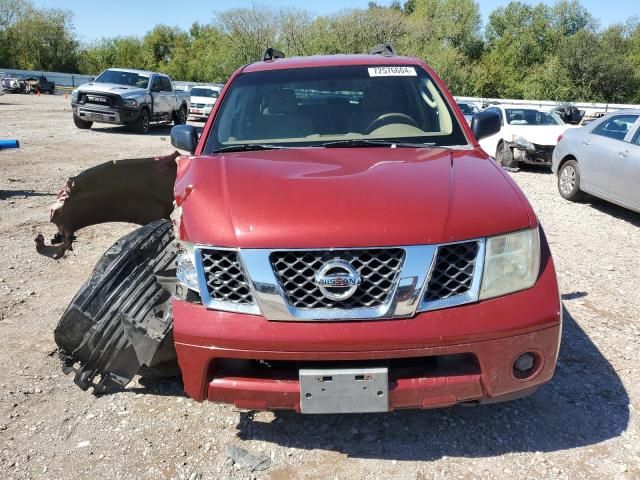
[{"x1": 480, "y1": 228, "x2": 540, "y2": 300}]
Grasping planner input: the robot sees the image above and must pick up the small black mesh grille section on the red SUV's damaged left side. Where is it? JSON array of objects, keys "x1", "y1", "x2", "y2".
[{"x1": 200, "y1": 249, "x2": 253, "y2": 305}]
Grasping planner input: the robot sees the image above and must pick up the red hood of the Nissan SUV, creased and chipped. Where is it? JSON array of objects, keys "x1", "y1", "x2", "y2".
[{"x1": 175, "y1": 148, "x2": 536, "y2": 248}]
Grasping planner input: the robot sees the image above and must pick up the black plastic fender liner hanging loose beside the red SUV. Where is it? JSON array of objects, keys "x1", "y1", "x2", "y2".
[{"x1": 54, "y1": 220, "x2": 180, "y2": 393}]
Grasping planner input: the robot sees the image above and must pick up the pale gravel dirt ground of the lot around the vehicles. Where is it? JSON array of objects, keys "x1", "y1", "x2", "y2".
[{"x1": 0, "y1": 95, "x2": 640, "y2": 480}]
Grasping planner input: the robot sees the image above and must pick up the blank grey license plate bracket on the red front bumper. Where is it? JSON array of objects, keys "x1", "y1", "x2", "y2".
[{"x1": 299, "y1": 367, "x2": 389, "y2": 413}]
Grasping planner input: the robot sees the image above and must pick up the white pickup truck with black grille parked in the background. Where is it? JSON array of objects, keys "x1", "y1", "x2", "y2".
[{"x1": 71, "y1": 68, "x2": 190, "y2": 133}]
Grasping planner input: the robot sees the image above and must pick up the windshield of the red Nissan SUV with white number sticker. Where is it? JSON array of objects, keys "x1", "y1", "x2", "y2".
[{"x1": 205, "y1": 66, "x2": 467, "y2": 153}]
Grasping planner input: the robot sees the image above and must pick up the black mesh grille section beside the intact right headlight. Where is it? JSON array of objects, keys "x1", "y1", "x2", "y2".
[{"x1": 424, "y1": 241, "x2": 480, "y2": 302}]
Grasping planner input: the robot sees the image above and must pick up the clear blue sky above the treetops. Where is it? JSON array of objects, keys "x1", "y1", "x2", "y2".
[{"x1": 33, "y1": 0, "x2": 640, "y2": 42}]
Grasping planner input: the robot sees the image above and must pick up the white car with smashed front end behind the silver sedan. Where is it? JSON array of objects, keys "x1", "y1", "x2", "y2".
[{"x1": 480, "y1": 105, "x2": 571, "y2": 170}]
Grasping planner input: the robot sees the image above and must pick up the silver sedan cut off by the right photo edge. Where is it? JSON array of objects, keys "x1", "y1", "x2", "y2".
[{"x1": 552, "y1": 110, "x2": 640, "y2": 212}]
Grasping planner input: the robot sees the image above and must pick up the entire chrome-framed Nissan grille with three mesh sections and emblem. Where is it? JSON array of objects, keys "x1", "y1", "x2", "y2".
[{"x1": 195, "y1": 242, "x2": 486, "y2": 322}]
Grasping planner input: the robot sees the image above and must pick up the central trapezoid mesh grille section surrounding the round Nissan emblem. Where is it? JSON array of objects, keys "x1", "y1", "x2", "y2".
[{"x1": 269, "y1": 248, "x2": 405, "y2": 310}]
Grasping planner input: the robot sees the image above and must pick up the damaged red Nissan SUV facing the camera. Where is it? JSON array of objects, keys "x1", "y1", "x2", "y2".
[{"x1": 164, "y1": 51, "x2": 561, "y2": 413}]
